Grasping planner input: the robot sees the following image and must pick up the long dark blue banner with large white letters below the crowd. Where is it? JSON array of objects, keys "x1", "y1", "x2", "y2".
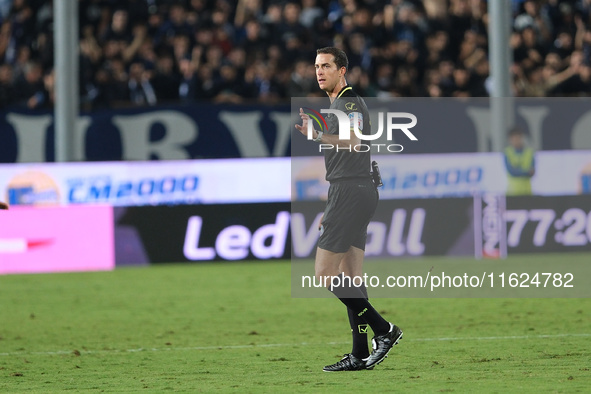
[{"x1": 0, "y1": 98, "x2": 591, "y2": 163}]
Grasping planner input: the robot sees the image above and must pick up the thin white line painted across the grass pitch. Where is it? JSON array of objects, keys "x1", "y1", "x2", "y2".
[{"x1": 0, "y1": 334, "x2": 591, "y2": 356}]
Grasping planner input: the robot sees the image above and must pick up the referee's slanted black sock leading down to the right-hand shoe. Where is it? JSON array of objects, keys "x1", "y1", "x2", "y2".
[{"x1": 329, "y1": 276, "x2": 390, "y2": 335}]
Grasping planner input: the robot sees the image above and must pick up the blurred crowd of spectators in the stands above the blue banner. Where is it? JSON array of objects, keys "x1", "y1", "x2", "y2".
[{"x1": 0, "y1": 0, "x2": 591, "y2": 109}]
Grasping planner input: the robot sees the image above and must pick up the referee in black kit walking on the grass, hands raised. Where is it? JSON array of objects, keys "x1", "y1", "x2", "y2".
[{"x1": 296, "y1": 47, "x2": 402, "y2": 372}]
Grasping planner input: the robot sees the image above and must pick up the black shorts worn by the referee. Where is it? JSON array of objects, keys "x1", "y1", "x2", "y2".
[{"x1": 318, "y1": 178, "x2": 379, "y2": 253}]
